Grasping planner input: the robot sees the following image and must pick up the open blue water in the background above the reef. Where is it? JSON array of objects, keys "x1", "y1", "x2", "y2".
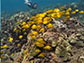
[{"x1": 1, "y1": 0, "x2": 77, "y2": 12}]
